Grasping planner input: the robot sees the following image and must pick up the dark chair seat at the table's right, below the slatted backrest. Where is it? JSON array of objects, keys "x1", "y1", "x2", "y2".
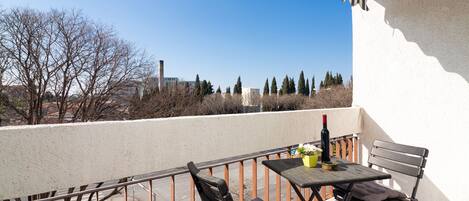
[{"x1": 334, "y1": 182, "x2": 407, "y2": 201}]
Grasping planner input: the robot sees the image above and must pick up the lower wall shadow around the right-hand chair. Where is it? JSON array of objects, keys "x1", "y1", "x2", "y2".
[{"x1": 360, "y1": 109, "x2": 449, "y2": 201}]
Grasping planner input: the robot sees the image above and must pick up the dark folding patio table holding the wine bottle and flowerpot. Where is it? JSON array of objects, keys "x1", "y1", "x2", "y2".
[{"x1": 262, "y1": 158, "x2": 391, "y2": 201}]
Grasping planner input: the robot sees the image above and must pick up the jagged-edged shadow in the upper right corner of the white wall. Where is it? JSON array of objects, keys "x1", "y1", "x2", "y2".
[{"x1": 375, "y1": 0, "x2": 469, "y2": 82}]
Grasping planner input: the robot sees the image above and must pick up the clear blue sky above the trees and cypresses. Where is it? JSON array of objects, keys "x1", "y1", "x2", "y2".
[{"x1": 0, "y1": 0, "x2": 352, "y2": 89}]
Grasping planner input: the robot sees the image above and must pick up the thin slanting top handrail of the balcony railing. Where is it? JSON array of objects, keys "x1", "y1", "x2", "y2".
[{"x1": 29, "y1": 134, "x2": 357, "y2": 201}]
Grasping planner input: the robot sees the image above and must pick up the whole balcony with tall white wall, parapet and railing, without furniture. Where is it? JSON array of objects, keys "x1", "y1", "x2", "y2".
[{"x1": 0, "y1": 0, "x2": 469, "y2": 201}]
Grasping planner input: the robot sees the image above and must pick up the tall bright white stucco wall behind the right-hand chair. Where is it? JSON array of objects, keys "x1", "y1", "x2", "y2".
[{"x1": 352, "y1": 0, "x2": 469, "y2": 201}]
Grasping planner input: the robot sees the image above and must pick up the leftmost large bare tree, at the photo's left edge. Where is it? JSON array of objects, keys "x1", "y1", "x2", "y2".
[{"x1": 0, "y1": 9, "x2": 59, "y2": 124}]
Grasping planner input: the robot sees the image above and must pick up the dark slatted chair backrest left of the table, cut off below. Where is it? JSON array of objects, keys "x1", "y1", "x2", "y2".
[{"x1": 187, "y1": 161, "x2": 233, "y2": 201}]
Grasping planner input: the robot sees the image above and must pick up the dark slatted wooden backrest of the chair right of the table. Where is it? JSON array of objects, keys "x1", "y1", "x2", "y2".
[{"x1": 368, "y1": 140, "x2": 428, "y2": 199}]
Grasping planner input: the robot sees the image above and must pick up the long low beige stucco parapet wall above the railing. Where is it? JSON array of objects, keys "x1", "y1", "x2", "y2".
[{"x1": 0, "y1": 108, "x2": 361, "y2": 200}]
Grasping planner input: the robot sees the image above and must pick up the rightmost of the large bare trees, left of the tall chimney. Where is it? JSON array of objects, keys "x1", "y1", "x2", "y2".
[{"x1": 73, "y1": 26, "x2": 152, "y2": 121}]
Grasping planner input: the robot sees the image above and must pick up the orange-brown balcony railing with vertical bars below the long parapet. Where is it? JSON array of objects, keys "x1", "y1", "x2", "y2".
[{"x1": 5, "y1": 134, "x2": 359, "y2": 201}]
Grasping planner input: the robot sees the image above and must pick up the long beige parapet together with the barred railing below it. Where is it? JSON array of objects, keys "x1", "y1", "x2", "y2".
[{"x1": 0, "y1": 107, "x2": 361, "y2": 201}]
